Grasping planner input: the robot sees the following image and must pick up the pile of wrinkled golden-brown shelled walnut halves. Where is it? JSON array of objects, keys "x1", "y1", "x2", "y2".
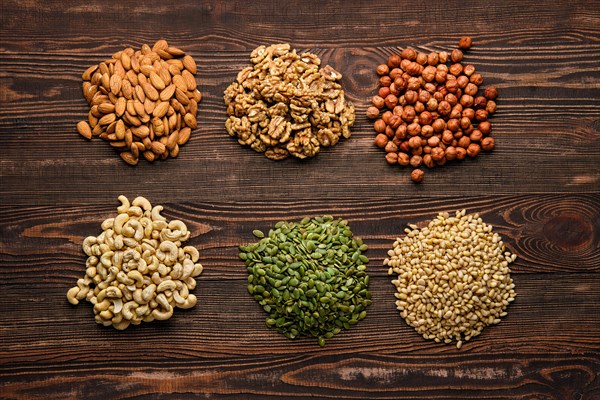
[{"x1": 224, "y1": 44, "x2": 354, "y2": 160}]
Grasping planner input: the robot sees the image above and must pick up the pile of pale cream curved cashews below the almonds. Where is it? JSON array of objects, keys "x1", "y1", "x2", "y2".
[{"x1": 67, "y1": 196, "x2": 202, "y2": 330}]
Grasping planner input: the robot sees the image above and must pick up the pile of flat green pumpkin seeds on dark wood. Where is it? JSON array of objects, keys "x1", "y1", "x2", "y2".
[{"x1": 240, "y1": 216, "x2": 371, "y2": 346}]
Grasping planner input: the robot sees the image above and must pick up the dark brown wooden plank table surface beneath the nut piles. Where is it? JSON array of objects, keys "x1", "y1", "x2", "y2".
[{"x1": 0, "y1": 0, "x2": 600, "y2": 400}]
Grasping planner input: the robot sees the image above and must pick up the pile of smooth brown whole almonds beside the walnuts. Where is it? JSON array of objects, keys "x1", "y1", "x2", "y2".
[{"x1": 77, "y1": 40, "x2": 202, "y2": 165}]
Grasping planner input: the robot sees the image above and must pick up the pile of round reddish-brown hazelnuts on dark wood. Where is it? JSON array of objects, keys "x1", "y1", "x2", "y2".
[{"x1": 367, "y1": 37, "x2": 498, "y2": 182}]
